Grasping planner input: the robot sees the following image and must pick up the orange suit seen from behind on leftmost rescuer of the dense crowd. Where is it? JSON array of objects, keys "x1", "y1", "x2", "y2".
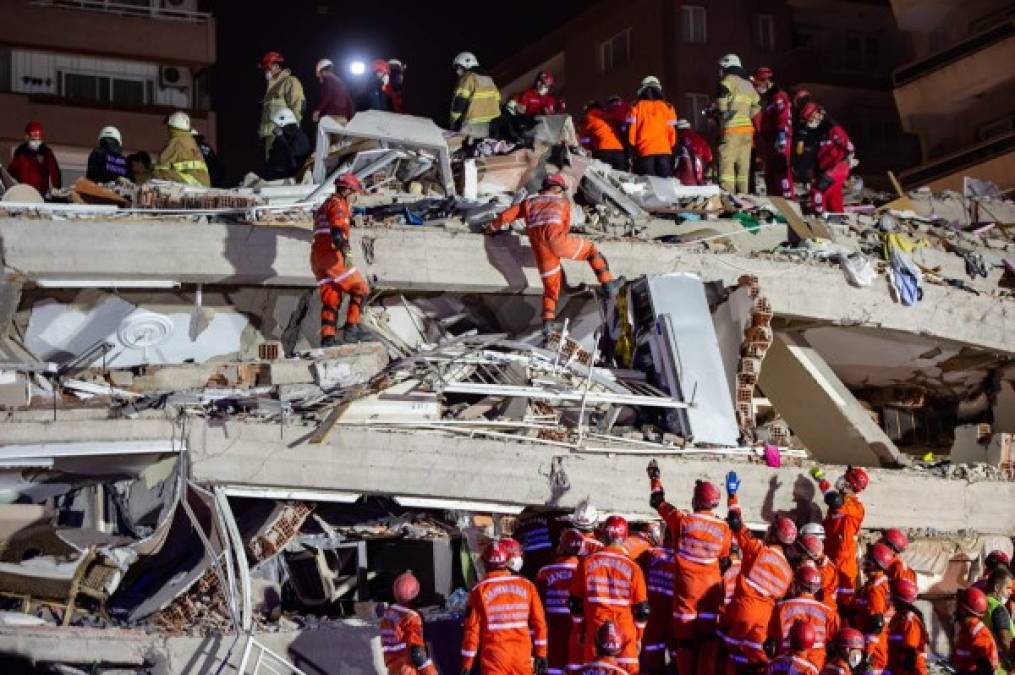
[{"x1": 462, "y1": 569, "x2": 547, "y2": 675}]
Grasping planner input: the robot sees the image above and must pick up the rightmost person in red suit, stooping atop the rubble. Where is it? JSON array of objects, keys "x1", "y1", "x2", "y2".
[{"x1": 800, "y1": 102, "x2": 854, "y2": 215}]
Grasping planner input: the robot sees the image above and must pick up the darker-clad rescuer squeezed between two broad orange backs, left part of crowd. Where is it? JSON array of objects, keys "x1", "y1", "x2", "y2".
[{"x1": 536, "y1": 530, "x2": 583, "y2": 675}]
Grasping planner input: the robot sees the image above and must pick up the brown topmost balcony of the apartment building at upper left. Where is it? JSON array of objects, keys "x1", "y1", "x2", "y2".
[{"x1": 0, "y1": 0, "x2": 215, "y2": 68}]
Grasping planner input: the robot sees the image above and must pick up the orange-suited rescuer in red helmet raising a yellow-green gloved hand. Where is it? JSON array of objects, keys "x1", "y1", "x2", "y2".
[{"x1": 811, "y1": 467, "x2": 870, "y2": 606}]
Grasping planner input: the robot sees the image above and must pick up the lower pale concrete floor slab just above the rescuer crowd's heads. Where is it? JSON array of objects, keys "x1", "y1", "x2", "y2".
[{"x1": 3, "y1": 419, "x2": 1015, "y2": 536}]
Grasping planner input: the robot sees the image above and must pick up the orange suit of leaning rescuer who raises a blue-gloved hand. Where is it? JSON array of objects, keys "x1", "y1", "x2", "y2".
[{"x1": 719, "y1": 519, "x2": 793, "y2": 667}]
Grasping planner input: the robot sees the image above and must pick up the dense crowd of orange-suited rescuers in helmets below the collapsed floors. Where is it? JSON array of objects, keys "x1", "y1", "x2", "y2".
[{"x1": 381, "y1": 461, "x2": 1013, "y2": 675}]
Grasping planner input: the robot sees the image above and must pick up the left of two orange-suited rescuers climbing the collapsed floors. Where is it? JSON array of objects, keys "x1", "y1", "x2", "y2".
[{"x1": 311, "y1": 195, "x2": 369, "y2": 338}]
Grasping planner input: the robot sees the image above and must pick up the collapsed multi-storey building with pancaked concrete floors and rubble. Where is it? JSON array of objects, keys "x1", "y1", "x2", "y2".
[{"x1": 0, "y1": 112, "x2": 1015, "y2": 673}]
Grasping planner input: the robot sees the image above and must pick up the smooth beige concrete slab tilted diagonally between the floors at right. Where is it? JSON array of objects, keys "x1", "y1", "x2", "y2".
[{"x1": 758, "y1": 333, "x2": 901, "y2": 467}]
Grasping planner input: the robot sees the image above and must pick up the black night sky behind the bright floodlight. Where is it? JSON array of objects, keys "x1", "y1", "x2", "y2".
[{"x1": 211, "y1": 0, "x2": 594, "y2": 184}]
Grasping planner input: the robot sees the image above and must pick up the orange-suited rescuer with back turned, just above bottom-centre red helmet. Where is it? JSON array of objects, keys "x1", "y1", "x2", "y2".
[{"x1": 570, "y1": 516, "x2": 650, "y2": 675}]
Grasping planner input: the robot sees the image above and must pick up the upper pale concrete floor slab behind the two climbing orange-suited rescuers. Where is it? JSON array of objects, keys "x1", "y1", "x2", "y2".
[{"x1": 0, "y1": 218, "x2": 1015, "y2": 353}]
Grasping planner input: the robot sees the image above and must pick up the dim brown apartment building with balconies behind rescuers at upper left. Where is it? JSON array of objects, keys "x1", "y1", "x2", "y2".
[{"x1": 0, "y1": 0, "x2": 215, "y2": 183}]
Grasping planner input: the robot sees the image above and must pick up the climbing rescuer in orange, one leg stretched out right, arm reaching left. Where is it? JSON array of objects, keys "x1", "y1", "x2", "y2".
[{"x1": 492, "y1": 194, "x2": 613, "y2": 321}]
